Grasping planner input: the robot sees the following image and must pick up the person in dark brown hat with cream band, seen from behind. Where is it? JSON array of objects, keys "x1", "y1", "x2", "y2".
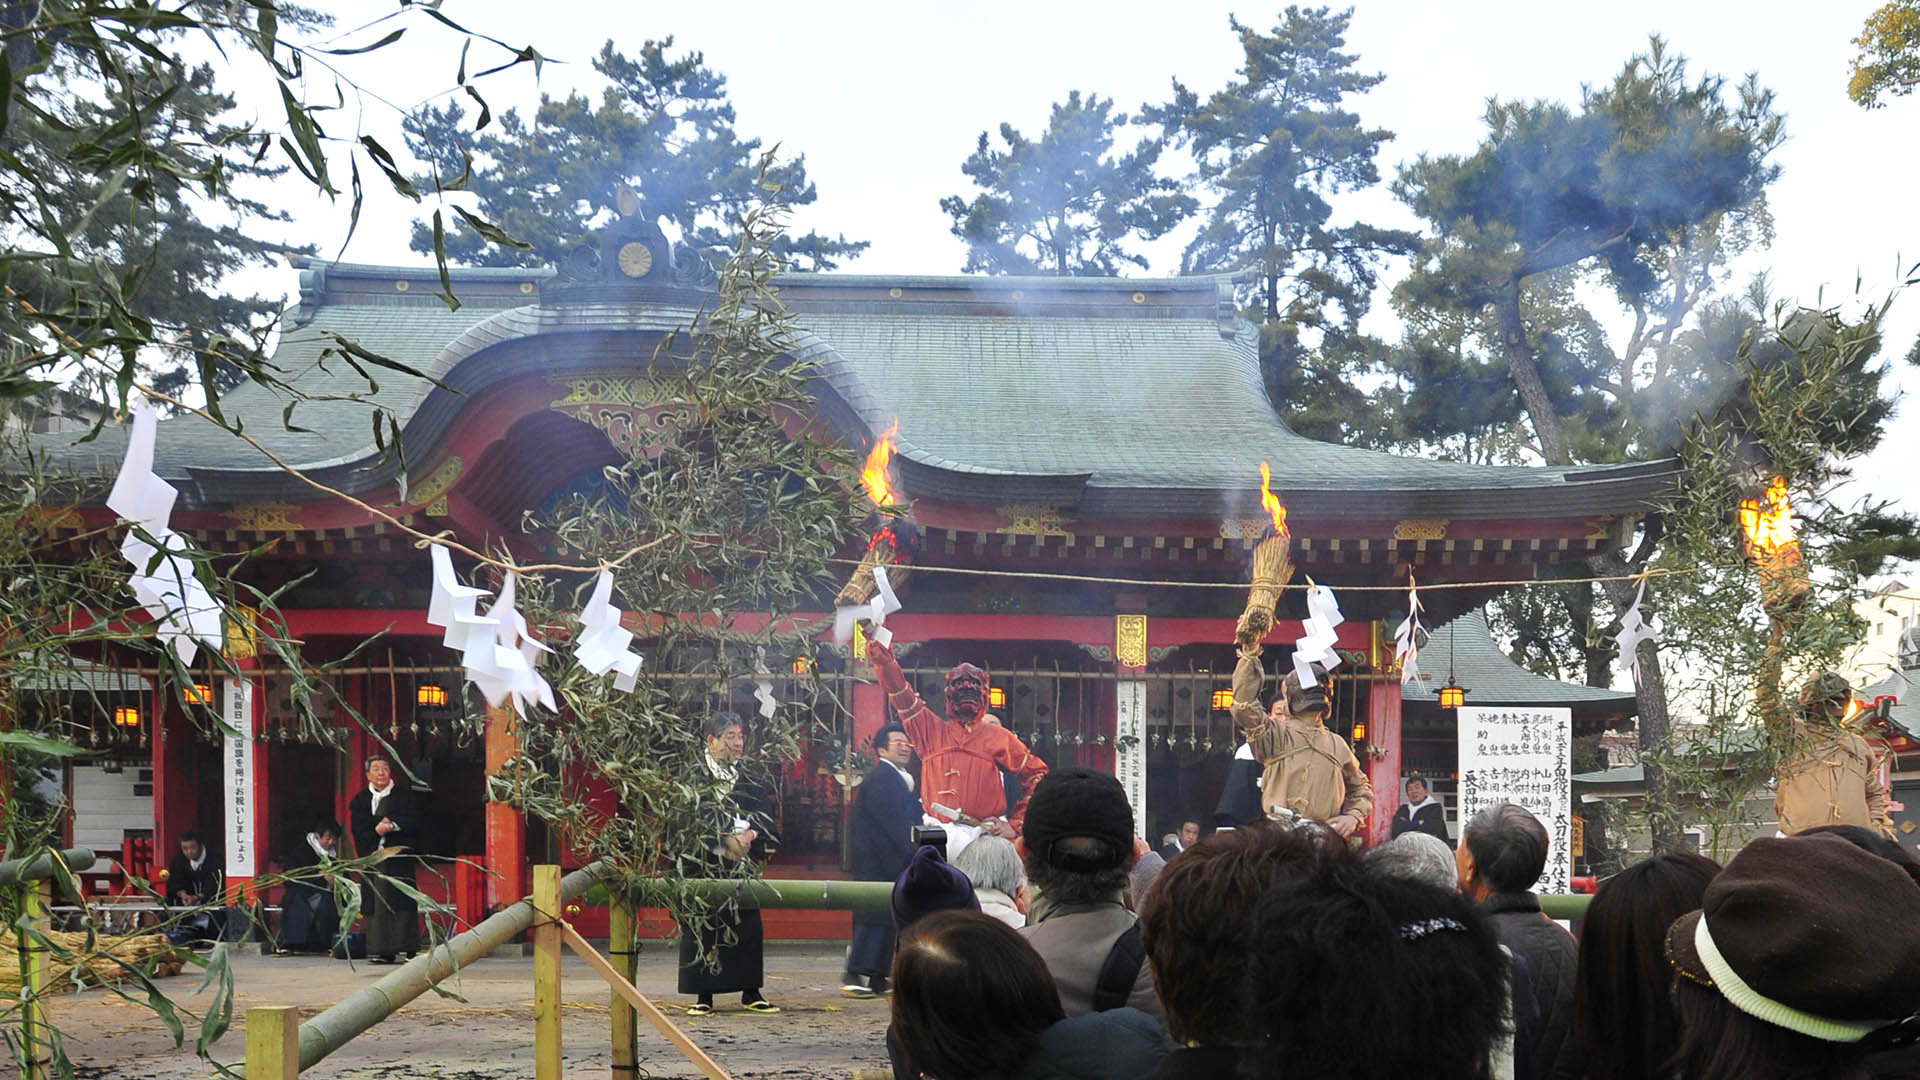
[{"x1": 1667, "y1": 836, "x2": 1920, "y2": 1080}]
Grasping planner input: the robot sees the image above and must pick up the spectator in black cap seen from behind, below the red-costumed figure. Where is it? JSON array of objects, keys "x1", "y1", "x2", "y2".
[{"x1": 1016, "y1": 765, "x2": 1162, "y2": 1017}]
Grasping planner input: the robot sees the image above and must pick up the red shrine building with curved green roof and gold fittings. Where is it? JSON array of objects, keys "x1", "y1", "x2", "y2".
[{"x1": 40, "y1": 238, "x2": 1674, "y2": 938}]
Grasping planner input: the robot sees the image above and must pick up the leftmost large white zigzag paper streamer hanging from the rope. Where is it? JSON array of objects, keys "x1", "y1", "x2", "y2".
[{"x1": 108, "y1": 396, "x2": 227, "y2": 665}]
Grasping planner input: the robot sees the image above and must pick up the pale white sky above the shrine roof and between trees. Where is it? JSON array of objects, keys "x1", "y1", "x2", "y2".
[{"x1": 267, "y1": 0, "x2": 1920, "y2": 526}]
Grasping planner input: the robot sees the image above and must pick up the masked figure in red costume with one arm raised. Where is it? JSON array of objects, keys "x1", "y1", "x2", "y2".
[{"x1": 866, "y1": 642, "x2": 1046, "y2": 838}]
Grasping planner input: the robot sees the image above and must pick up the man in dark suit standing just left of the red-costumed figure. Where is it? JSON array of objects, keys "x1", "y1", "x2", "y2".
[{"x1": 841, "y1": 724, "x2": 920, "y2": 997}]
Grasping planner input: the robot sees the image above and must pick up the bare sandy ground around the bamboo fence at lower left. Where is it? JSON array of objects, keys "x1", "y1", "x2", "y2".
[{"x1": 54, "y1": 942, "x2": 887, "y2": 1080}]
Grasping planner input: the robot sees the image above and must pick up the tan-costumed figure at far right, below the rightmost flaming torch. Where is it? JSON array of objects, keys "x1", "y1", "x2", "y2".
[{"x1": 1772, "y1": 671, "x2": 1893, "y2": 836}]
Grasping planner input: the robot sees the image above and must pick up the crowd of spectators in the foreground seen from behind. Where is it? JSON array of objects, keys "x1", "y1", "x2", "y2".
[{"x1": 872, "y1": 769, "x2": 1920, "y2": 1080}]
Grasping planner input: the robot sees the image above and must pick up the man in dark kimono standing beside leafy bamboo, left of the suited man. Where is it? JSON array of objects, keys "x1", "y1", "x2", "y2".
[{"x1": 680, "y1": 713, "x2": 780, "y2": 1017}]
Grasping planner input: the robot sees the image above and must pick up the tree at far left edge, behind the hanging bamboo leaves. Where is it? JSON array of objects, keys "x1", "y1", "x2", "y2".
[{"x1": 0, "y1": 50, "x2": 313, "y2": 394}]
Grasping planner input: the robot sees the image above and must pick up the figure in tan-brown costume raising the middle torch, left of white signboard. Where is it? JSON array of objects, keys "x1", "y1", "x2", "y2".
[{"x1": 1233, "y1": 634, "x2": 1373, "y2": 838}]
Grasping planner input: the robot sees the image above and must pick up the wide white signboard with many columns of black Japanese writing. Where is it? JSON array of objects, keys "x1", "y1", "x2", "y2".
[{"x1": 1459, "y1": 705, "x2": 1572, "y2": 892}]
